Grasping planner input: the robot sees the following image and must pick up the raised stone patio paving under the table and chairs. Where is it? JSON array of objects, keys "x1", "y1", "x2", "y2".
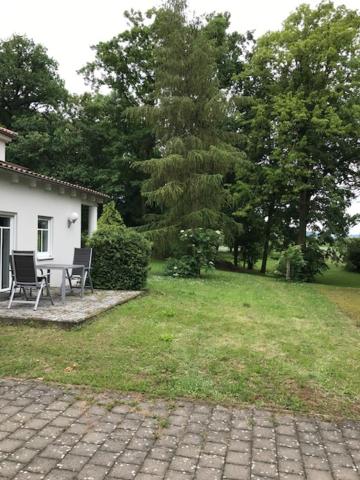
[{"x1": 0, "y1": 289, "x2": 142, "y2": 326}]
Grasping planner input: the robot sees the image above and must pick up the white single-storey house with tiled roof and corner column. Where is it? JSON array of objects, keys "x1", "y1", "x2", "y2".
[{"x1": 0, "y1": 127, "x2": 107, "y2": 292}]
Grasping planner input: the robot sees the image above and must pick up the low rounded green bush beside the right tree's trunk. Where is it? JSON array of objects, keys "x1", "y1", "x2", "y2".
[{"x1": 277, "y1": 240, "x2": 328, "y2": 282}]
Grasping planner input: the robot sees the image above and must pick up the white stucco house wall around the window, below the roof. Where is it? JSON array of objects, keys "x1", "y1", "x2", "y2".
[{"x1": 0, "y1": 169, "x2": 96, "y2": 285}]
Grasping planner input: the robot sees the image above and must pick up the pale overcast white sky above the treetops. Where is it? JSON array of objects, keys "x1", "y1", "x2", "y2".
[{"x1": 0, "y1": 0, "x2": 360, "y2": 233}]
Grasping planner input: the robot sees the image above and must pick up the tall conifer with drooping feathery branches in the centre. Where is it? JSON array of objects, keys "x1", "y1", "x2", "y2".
[{"x1": 135, "y1": 0, "x2": 238, "y2": 248}]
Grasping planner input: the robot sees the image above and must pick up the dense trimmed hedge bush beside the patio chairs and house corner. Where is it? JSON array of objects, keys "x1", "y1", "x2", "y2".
[{"x1": 88, "y1": 204, "x2": 151, "y2": 290}]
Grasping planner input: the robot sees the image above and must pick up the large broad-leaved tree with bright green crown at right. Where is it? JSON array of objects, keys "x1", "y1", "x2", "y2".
[{"x1": 233, "y1": 2, "x2": 360, "y2": 272}]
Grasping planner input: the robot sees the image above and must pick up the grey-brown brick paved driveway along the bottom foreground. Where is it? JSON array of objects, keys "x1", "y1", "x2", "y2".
[{"x1": 0, "y1": 379, "x2": 360, "y2": 480}]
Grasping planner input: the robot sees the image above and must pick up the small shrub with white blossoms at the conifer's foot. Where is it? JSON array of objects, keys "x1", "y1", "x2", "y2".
[{"x1": 165, "y1": 227, "x2": 223, "y2": 277}]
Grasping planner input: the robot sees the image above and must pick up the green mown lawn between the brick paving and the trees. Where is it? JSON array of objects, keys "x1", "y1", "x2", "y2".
[{"x1": 0, "y1": 263, "x2": 360, "y2": 417}]
